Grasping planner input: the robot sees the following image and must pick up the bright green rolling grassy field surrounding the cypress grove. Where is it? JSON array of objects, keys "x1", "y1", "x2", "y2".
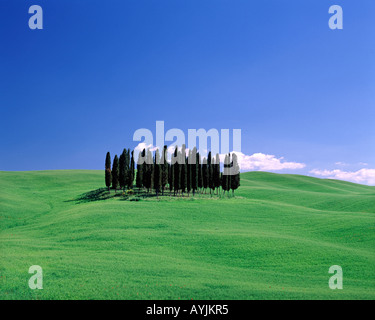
[{"x1": 0, "y1": 170, "x2": 375, "y2": 300}]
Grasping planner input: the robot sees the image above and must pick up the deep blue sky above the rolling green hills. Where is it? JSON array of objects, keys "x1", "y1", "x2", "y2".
[{"x1": 0, "y1": 0, "x2": 375, "y2": 184}]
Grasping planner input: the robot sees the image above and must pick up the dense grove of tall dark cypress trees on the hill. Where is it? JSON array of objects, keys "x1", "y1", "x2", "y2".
[{"x1": 105, "y1": 145, "x2": 240, "y2": 197}]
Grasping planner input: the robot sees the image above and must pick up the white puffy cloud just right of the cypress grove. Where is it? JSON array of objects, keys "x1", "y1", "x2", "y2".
[{"x1": 225, "y1": 152, "x2": 306, "y2": 171}]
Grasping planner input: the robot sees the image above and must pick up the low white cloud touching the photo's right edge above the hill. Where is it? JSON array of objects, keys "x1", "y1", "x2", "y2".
[{"x1": 310, "y1": 168, "x2": 375, "y2": 185}]
